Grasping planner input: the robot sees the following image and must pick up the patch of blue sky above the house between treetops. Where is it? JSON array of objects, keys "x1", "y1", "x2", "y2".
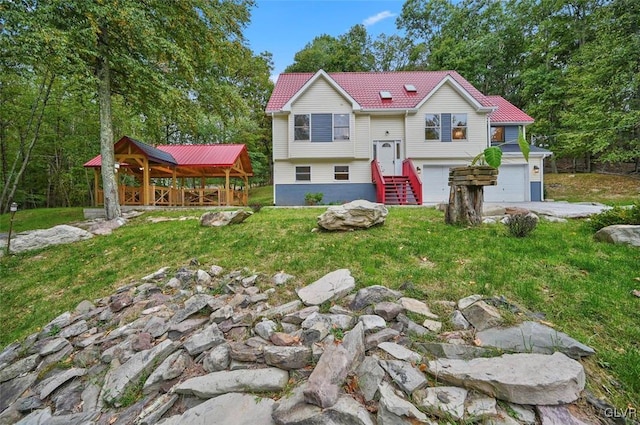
[{"x1": 244, "y1": 0, "x2": 404, "y2": 76}]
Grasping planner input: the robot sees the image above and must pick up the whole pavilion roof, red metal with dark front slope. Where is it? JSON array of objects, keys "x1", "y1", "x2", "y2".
[{"x1": 84, "y1": 136, "x2": 253, "y2": 174}]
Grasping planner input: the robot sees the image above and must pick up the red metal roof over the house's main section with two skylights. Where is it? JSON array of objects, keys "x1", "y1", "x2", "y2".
[{"x1": 266, "y1": 71, "x2": 493, "y2": 112}]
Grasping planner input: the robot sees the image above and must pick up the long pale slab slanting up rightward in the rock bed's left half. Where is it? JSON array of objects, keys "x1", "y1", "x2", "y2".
[{"x1": 100, "y1": 340, "x2": 177, "y2": 404}]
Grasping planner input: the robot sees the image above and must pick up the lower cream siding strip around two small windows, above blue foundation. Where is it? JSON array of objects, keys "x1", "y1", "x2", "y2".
[{"x1": 273, "y1": 160, "x2": 371, "y2": 184}]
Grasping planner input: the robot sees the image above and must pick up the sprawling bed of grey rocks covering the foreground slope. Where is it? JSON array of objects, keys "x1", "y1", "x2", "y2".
[{"x1": 0, "y1": 261, "x2": 613, "y2": 425}]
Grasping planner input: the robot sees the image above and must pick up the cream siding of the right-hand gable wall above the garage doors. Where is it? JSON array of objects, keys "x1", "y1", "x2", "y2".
[{"x1": 406, "y1": 83, "x2": 488, "y2": 160}]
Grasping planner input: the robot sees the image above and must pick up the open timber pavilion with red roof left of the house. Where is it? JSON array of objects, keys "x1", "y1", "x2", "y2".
[{"x1": 84, "y1": 136, "x2": 253, "y2": 206}]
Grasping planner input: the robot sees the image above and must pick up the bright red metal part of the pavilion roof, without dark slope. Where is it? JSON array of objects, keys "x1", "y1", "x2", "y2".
[{"x1": 84, "y1": 136, "x2": 253, "y2": 174}]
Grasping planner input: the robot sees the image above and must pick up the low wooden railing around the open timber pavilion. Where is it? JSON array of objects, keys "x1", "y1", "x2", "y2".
[{"x1": 96, "y1": 186, "x2": 249, "y2": 207}]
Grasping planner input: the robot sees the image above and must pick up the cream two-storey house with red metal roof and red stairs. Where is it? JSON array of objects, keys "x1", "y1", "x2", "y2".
[{"x1": 266, "y1": 70, "x2": 550, "y2": 205}]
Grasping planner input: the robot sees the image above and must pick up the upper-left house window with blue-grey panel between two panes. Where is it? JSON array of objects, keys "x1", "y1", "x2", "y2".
[{"x1": 293, "y1": 114, "x2": 350, "y2": 142}]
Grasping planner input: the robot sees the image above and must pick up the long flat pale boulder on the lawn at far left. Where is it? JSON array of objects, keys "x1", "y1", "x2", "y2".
[{"x1": 5, "y1": 224, "x2": 93, "y2": 254}]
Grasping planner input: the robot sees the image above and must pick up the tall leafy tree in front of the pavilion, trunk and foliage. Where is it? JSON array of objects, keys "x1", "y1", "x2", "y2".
[{"x1": 5, "y1": 0, "x2": 253, "y2": 219}]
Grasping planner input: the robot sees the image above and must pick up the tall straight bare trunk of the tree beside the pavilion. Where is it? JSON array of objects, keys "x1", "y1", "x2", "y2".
[{"x1": 96, "y1": 31, "x2": 122, "y2": 220}]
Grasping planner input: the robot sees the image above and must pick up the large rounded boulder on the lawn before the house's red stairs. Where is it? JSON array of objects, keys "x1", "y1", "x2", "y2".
[{"x1": 318, "y1": 199, "x2": 389, "y2": 230}]
